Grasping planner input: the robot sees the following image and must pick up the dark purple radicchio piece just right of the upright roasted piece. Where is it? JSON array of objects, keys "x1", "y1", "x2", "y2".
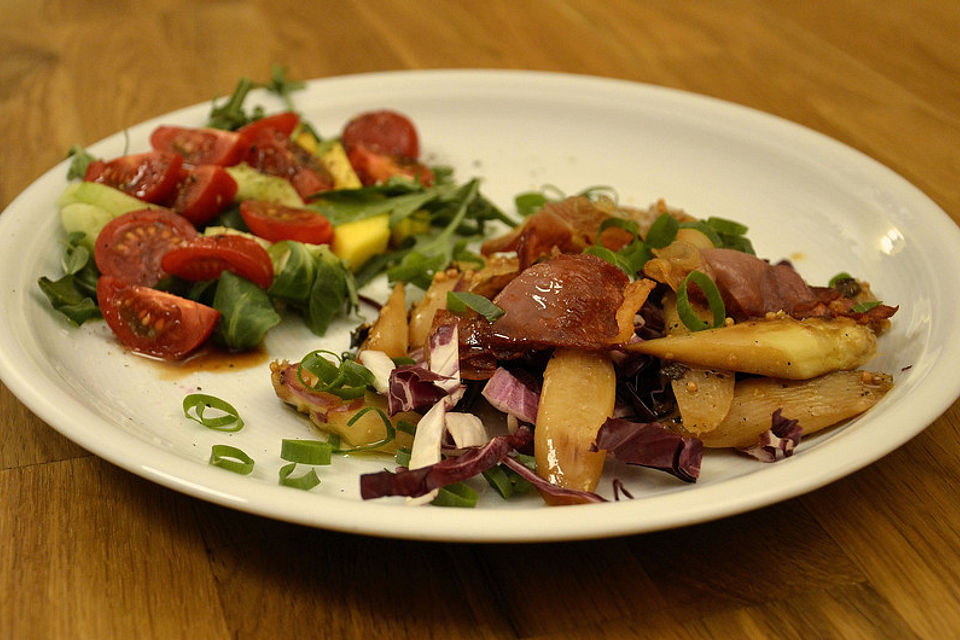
[{"x1": 590, "y1": 418, "x2": 703, "y2": 482}]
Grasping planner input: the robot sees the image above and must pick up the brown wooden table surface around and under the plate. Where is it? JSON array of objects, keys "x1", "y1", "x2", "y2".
[{"x1": 0, "y1": 0, "x2": 960, "y2": 638}]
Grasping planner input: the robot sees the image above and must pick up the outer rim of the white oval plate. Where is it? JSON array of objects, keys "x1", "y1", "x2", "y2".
[{"x1": 0, "y1": 69, "x2": 960, "y2": 542}]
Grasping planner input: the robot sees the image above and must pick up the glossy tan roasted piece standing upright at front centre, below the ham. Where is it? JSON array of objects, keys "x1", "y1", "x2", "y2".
[{"x1": 534, "y1": 349, "x2": 617, "y2": 504}]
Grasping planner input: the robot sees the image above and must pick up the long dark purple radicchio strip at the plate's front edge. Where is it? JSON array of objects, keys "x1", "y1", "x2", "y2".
[{"x1": 360, "y1": 428, "x2": 533, "y2": 500}]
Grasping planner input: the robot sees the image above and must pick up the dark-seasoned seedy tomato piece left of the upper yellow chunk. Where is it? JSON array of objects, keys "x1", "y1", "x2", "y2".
[{"x1": 247, "y1": 129, "x2": 333, "y2": 198}]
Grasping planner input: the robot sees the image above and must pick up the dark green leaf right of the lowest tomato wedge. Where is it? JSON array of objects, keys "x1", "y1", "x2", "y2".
[{"x1": 213, "y1": 271, "x2": 280, "y2": 351}]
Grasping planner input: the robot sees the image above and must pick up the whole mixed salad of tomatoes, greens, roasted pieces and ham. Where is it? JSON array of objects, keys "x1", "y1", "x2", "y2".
[{"x1": 39, "y1": 72, "x2": 896, "y2": 506}]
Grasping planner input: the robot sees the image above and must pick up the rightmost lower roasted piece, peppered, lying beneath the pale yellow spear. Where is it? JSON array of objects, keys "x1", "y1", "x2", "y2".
[{"x1": 699, "y1": 371, "x2": 893, "y2": 447}]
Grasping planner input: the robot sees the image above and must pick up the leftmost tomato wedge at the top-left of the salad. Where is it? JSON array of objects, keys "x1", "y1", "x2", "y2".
[{"x1": 83, "y1": 151, "x2": 183, "y2": 204}]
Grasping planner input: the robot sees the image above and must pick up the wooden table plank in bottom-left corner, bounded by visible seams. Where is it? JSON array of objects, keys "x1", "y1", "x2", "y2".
[{"x1": 0, "y1": 457, "x2": 230, "y2": 639}]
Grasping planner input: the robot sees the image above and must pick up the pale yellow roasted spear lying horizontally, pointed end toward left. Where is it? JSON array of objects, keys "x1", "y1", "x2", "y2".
[{"x1": 625, "y1": 317, "x2": 877, "y2": 380}]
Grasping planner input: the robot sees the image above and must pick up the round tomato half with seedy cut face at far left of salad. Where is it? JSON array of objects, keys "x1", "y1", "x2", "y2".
[{"x1": 93, "y1": 209, "x2": 197, "y2": 287}]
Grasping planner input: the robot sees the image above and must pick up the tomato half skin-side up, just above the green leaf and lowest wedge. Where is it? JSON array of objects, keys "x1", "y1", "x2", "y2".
[{"x1": 161, "y1": 235, "x2": 273, "y2": 289}]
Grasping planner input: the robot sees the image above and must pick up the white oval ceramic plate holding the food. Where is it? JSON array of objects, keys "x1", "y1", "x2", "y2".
[{"x1": 0, "y1": 71, "x2": 960, "y2": 541}]
